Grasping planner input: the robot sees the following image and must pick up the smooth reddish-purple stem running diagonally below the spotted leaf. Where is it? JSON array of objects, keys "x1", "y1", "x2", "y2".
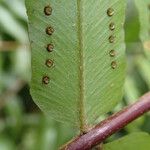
[{"x1": 61, "y1": 92, "x2": 150, "y2": 150}]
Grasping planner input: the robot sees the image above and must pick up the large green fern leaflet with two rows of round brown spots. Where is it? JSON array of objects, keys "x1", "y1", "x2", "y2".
[{"x1": 26, "y1": 0, "x2": 126, "y2": 130}]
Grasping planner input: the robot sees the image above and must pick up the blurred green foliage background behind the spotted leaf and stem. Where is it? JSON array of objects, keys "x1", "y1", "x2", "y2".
[{"x1": 0, "y1": 0, "x2": 150, "y2": 150}]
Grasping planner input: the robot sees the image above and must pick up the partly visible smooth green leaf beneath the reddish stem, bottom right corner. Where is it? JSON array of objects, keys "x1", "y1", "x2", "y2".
[{"x1": 104, "y1": 132, "x2": 150, "y2": 150}]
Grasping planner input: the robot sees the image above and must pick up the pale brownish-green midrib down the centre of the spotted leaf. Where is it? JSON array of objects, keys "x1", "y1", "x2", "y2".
[{"x1": 77, "y1": 0, "x2": 86, "y2": 133}]
